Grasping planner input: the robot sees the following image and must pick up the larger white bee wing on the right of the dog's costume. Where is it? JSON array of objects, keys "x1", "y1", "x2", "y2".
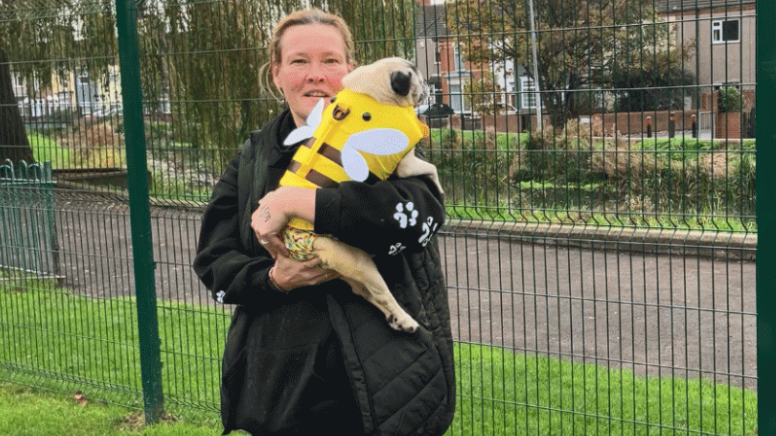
[{"x1": 342, "y1": 128, "x2": 410, "y2": 182}]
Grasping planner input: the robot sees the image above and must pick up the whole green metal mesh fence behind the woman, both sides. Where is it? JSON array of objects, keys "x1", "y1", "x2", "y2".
[{"x1": 0, "y1": 0, "x2": 772, "y2": 435}]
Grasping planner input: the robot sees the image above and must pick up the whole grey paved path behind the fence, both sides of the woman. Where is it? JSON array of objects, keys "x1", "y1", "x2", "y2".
[{"x1": 51, "y1": 200, "x2": 756, "y2": 388}]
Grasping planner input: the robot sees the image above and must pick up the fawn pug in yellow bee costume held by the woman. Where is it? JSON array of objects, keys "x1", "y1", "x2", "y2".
[{"x1": 272, "y1": 57, "x2": 444, "y2": 333}]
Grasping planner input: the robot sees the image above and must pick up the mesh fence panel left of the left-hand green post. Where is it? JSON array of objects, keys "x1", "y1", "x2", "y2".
[{"x1": 0, "y1": 1, "x2": 143, "y2": 408}]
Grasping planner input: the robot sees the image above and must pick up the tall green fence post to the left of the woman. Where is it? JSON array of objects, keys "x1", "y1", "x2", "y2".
[{"x1": 116, "y1": 0, "x2": 163, "y2": 423}]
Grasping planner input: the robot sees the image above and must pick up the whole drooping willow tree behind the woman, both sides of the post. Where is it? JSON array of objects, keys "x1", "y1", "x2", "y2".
[{"x1": 0, "y1": 0, "x2": 415, "y2": 167}]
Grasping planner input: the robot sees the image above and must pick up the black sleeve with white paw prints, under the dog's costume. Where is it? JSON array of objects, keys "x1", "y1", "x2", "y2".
[{"x1": 315, "y1": 148, "x2": 445, "y2": 256}]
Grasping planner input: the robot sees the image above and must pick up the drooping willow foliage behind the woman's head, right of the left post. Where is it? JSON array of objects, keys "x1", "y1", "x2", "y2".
[{"x1": 138, "y1": 0, "x2": 414, "y2": 167}]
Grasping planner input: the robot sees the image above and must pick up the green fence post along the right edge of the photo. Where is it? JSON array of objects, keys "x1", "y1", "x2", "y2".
[{"x1": 756, "y1": 1, "x2": 776, "y2": 434}]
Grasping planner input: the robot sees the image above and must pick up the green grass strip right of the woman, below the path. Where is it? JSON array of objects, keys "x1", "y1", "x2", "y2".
[{"x1": 451, "y1": 344, "x2": 757, "y2": 436}]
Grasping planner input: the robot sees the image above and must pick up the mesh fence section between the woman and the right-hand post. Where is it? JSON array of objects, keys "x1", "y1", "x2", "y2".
[{"x1": 424, "y1": 0, "x2": 762, "y2": 435}]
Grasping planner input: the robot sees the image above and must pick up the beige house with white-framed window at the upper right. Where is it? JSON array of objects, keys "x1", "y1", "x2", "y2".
[{"x1": 657, "y1": 0, "x2": 757, "y2": 117}]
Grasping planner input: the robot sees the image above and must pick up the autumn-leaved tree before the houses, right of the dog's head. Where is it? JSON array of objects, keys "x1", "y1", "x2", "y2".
[{"x1": 448, "y1": 0, "x2": 689, "y2": 128}]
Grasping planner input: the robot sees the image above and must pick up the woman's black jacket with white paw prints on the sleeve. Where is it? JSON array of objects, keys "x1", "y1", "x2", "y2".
[{"x1": 194, "y1": 111, "x2": 455, "y2": 436}]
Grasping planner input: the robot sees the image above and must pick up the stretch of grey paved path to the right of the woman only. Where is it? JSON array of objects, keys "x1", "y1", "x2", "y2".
[{"x1": 441, "y1": 232, "x2": 757, "y2": 388}]
